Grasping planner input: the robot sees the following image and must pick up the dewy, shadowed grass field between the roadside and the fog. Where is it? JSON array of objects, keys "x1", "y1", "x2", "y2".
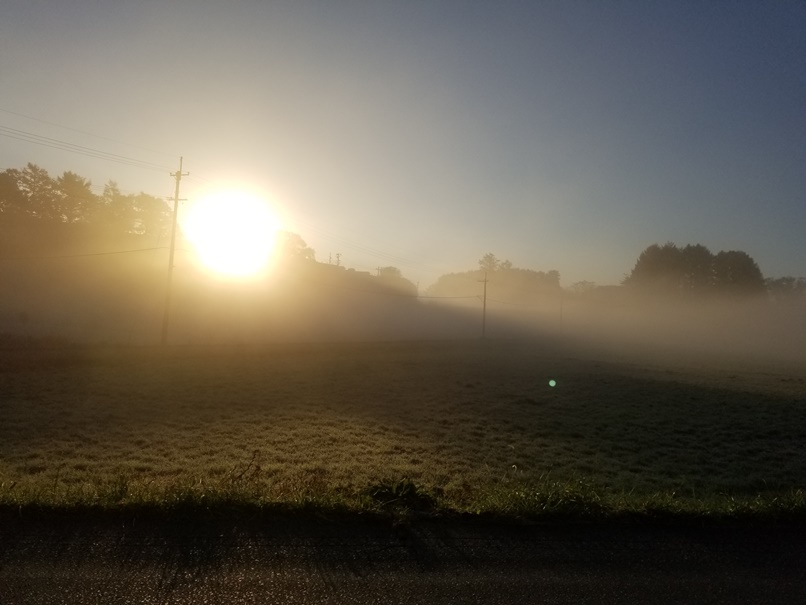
[{"x1": 0, "y1": 341, "x2": 806, "y2": 517}]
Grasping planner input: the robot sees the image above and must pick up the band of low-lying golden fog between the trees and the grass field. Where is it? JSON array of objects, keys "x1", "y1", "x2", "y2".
[{"x1": 0, "y1": 256, "x2": 806, "y2": 362}]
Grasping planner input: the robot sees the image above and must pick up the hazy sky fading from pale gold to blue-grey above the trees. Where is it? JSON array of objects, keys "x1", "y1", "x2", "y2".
[{"x1": 0, "y1": 0, "x2": 806, "y2": 287}]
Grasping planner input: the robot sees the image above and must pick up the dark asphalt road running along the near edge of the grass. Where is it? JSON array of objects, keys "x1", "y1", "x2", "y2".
[{"x1": 0, "y1": 515, "x2": 806, "y2": 605}]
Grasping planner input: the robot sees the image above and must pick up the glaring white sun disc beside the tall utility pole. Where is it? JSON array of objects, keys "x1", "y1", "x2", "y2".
[{"x1": 182, "y1": 190, "x2": 280, "y2": 277}]
